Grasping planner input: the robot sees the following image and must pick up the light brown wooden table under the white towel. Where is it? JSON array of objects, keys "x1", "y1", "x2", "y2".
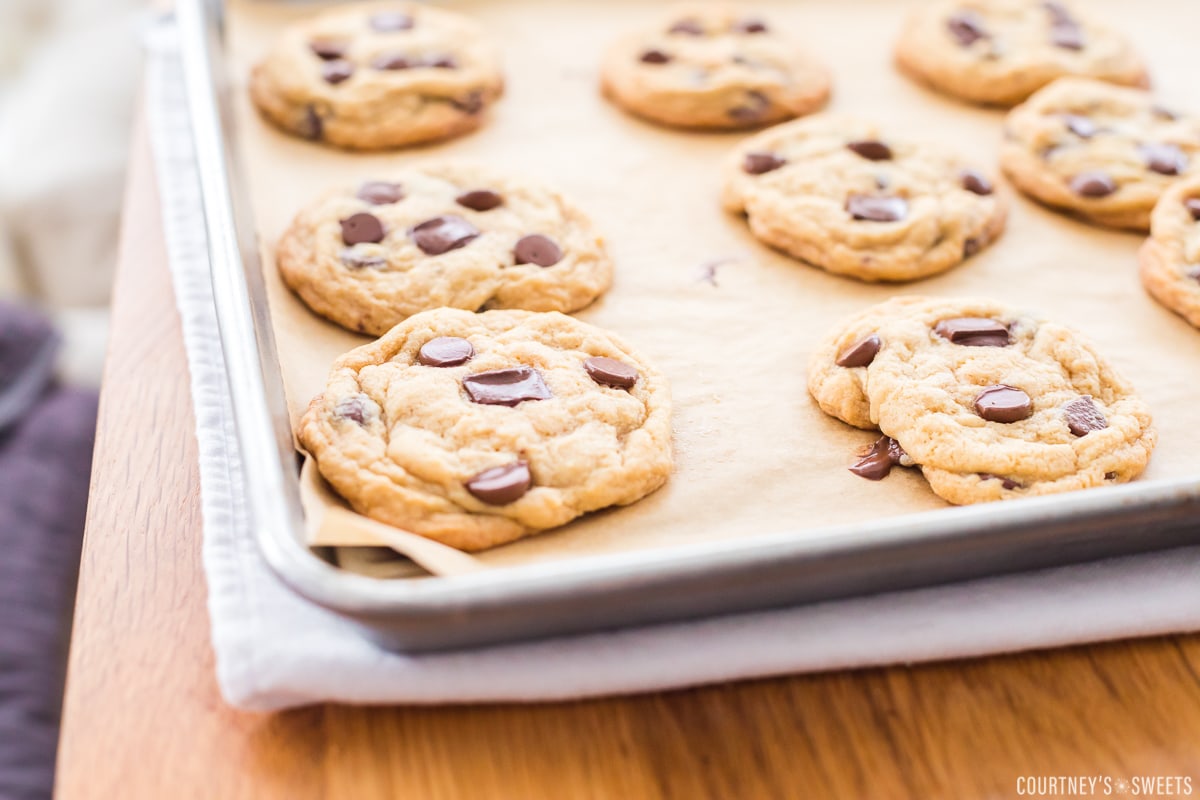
[{"x1": 58, "y1": 112, "x2": 1200, "y2": 800}]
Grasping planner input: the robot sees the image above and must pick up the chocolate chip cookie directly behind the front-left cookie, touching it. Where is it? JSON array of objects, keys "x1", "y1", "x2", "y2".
[{"x1": 277, "y1": 162, "x2": 612, "y2": 336}]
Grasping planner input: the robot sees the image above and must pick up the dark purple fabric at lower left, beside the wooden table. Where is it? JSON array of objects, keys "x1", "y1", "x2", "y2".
[{"x1": 0, "y1": 387, "x2": 96, "y2": 800}]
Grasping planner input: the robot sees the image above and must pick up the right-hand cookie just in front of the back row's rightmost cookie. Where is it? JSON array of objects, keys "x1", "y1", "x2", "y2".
[{"x1": 1001, "y1": 78, "x2": 1200, "y2": 230}]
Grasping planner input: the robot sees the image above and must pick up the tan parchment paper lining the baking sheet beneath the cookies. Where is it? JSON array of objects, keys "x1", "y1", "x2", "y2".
[{"x1": 229, "y1": 0, "x2": 1200, "y2": 575}]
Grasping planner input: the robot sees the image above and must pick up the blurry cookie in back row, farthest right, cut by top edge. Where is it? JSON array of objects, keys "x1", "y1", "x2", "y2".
[{"x1": 895, "y1": 0, "x2": 1148, "y2": 106}]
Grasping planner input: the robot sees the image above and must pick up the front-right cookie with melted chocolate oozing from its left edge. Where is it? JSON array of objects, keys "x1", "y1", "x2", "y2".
[{"x1": 810, "y1": 297, "x2": 1157, "y2": 504}]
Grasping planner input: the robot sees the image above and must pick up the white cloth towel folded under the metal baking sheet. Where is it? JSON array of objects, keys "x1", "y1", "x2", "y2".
[{"x1": 148, "y1": 18, "x2": 1200, "y2": 710}]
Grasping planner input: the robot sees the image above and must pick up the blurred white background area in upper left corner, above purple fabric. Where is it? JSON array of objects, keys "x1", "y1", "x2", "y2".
[{"x1": 0, "y1": 0, "x2": 145, "y2": 385}]
